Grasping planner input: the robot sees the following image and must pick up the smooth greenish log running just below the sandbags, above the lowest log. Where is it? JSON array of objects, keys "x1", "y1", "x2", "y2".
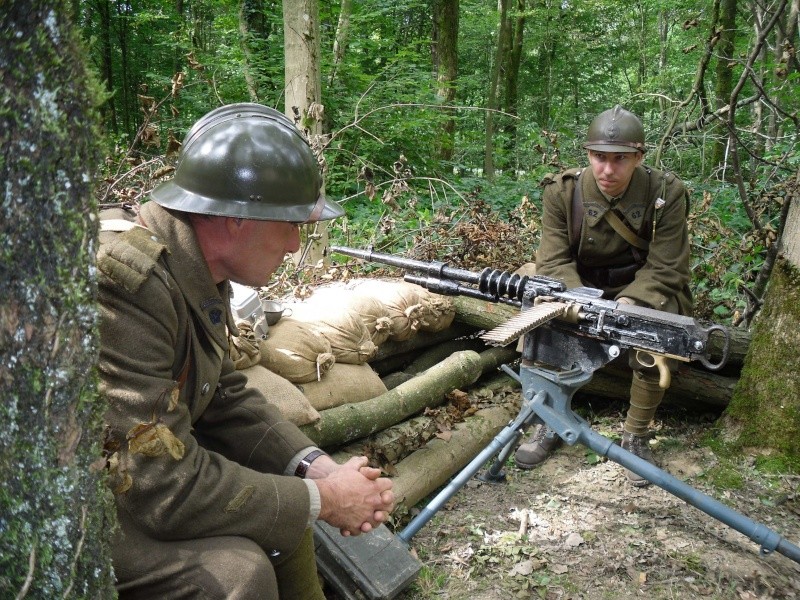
[{"x1": 300, "y1": 350, "x2": 490, "y2": 448}]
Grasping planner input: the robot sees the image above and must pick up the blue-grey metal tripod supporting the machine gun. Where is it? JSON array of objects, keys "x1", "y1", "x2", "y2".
[{"x1": 397, "y1": 364, "x2": 800, "y2": 563}]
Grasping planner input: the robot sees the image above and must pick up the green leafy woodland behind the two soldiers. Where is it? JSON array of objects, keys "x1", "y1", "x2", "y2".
[{"x1": 84, "y1": 0, "x2": 800, "y2": 322}]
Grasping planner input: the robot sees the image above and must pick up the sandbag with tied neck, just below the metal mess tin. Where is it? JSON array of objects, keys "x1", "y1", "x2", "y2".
[{"x1": 259, "y1": 318, "x2": 336, "y2": 383}]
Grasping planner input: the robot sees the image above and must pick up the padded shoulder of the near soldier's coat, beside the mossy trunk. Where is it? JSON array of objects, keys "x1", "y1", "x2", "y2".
[{"x1": 97, "y1": 213, "x2": 167, "y2": 293}]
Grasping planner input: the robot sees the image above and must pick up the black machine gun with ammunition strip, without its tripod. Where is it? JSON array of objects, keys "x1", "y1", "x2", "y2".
[{"x1": 331, "y1": 246, "x2": 730, "y2": 372}]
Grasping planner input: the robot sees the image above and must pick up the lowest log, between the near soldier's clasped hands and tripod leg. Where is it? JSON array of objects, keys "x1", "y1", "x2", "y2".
[{"x1": 393, "y1": 406, "x2": 514, "y2": 514}]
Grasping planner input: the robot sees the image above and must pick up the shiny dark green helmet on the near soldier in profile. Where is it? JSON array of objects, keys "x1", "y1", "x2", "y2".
[{"x1": 151, "y1": 103, "x2": 344, "y2": 223}]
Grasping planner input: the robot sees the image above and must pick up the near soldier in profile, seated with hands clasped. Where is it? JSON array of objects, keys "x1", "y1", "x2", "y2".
[{"x1": 97, "y1": 104, "x2": 394, "y2": 600}]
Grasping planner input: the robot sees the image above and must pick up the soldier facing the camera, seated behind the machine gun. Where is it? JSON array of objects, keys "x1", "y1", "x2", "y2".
[{"x1": 515, "y1": 105, "x2": 693, "y2": 486}]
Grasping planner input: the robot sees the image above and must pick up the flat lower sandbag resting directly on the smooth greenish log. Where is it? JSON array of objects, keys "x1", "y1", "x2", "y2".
[{"x1": 298, "y1": 362, "x2": 386, "y2": 411}]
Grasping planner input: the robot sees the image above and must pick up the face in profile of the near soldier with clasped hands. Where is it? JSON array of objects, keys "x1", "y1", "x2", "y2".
[{"x1": 228, "y1": 219, "x2": 300, "y2": 287}]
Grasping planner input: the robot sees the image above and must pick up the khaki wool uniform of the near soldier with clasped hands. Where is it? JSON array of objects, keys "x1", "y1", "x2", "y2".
[{"x1": 98, "y1": 202, "x2": 322, "y2": 598}]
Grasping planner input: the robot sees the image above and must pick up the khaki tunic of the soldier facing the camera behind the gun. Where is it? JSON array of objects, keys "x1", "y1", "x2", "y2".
[{"x1": 536, "y1": 166, "x2": 692, "y2": 315}]
